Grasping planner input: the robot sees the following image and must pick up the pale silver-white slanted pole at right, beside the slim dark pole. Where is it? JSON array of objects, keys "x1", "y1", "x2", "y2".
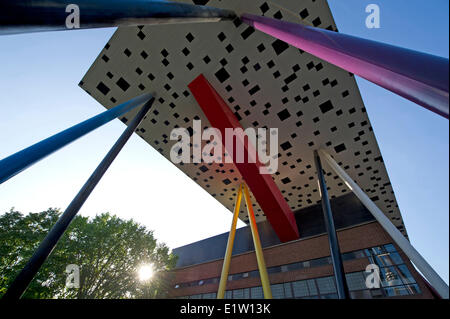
[{"x1": 319, "y1": 149, "x2": 449, "y2": 299}]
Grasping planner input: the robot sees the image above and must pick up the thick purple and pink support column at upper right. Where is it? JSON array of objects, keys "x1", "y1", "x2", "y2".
[{"x1": 241, "y1": 14, "x2": 449, "y2": 119}]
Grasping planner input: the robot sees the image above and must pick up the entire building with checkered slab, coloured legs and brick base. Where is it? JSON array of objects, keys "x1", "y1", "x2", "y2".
[{"x1": 0, "y1": 0, "x2": 449, "y2": 299}]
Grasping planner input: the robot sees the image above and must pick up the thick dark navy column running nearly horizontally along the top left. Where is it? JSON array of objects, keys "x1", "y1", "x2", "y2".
[{"x1": 0, "y1": 0, "x2": 236, "y2": 35}]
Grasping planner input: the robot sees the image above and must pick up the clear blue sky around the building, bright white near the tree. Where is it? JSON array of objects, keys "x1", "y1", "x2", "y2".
[{"x1": 0, "y1": 0, "x2": 449, "y2": 282}]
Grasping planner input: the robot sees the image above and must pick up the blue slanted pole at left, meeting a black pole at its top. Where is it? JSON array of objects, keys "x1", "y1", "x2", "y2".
[{"x1": 0, "y1": 94, "x2": 152, "y2": 184}]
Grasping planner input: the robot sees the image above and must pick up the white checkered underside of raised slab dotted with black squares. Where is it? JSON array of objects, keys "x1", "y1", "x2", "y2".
[{"x1": 80, "y1": 0, "x2": 406, "y2": 239}]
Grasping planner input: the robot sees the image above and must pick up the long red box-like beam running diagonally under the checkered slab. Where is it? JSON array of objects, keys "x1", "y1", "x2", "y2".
[{"x1": 189, "y1": 74, "x2": 299, "y2": 242}]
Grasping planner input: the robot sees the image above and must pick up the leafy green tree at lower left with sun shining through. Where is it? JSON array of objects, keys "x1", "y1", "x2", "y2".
[{"x1": 0, "y1": 208, "x2": 176, "y2": 299}]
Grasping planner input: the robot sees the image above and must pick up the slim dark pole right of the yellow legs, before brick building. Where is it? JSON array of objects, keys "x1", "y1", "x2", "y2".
[{"x1": 314, "y1": 151, "x2": 350, "y2": 299}]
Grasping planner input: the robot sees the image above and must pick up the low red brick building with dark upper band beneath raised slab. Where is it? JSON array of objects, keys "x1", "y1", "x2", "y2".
[{"x1": 170, "y1": 195, "x2": 435, "y2": 299}]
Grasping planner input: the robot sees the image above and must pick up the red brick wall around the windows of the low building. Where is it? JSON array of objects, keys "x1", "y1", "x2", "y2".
[{"x1": 170, "y1": 222, "x2": 433, "y2": 298}]
